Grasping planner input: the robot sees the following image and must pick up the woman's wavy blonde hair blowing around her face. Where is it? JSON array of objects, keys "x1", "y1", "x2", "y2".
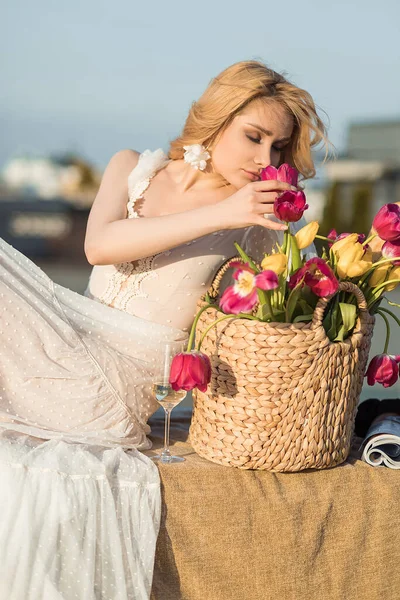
[{"x1": 169, "y1": 60, "x2": 331, "y2": 179}]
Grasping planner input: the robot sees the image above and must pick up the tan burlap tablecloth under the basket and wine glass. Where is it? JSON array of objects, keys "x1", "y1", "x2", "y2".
[{"x1": 146, "y1": 409, "x2": 400, "y2": 600}]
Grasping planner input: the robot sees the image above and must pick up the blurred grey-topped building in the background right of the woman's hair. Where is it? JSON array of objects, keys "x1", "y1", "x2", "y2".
[{"x1": 321, "y1": 120, "x2": 400, "y2": 233}]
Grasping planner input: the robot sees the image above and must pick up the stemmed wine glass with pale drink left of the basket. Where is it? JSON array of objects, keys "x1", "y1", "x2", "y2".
[{"x1": 152, "y1": 341, "x2": 187, "y2": 464}]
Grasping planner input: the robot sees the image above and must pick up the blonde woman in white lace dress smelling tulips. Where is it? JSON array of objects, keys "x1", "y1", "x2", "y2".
[{"x1": 0, "y1": 61, "x2": 326, "y2": 600}]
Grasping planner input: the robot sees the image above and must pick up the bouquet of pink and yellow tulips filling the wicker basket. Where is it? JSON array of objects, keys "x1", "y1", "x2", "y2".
[{"x1": 170, "y1": 164, "x2": 400, "y2": 392}]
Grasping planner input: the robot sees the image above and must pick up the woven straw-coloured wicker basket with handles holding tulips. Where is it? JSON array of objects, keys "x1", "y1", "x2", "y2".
[{"x1": 189, "y1": 257, "x2": 375, "y2": 472}]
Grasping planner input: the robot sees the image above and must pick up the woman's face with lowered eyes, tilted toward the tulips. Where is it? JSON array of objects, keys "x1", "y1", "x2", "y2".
[{"x1": 211, "y1": 100, "x2": 293, "y2": 189}]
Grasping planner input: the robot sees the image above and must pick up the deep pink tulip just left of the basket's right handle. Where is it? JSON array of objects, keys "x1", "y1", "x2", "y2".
[{"x1": 289, "y1": 257, "x2": 339, "y2": 298}]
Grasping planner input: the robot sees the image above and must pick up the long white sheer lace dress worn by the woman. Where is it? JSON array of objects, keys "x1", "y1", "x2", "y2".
[{"x1": 0, "y1": 150, "x2": 312, "y2": 600}]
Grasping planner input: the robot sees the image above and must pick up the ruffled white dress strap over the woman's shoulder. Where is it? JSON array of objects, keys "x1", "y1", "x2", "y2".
[{"x1": 127, "y1": 148, "x2": 170, "y2": 219}]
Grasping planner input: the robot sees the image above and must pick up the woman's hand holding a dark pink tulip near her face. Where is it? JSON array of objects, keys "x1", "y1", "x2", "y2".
[{"x1": 216, "y1": 180, "x2": 297, "y2": 231}]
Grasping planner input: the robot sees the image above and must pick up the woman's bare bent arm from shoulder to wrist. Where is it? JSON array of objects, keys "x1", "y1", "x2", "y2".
[{"x1": 85, "y1": 150, "x2": 234, "y2": 265}]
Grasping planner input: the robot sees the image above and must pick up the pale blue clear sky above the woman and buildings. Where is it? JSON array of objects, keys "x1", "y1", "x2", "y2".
[{"x1": 0, "y1": 0, "x2": 400, "y2": 168}]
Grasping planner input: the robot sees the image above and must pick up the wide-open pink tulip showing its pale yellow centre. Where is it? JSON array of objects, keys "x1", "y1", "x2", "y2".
[{"x1": 219, "y1": 261, "x2": 279, "y2": 315}]
